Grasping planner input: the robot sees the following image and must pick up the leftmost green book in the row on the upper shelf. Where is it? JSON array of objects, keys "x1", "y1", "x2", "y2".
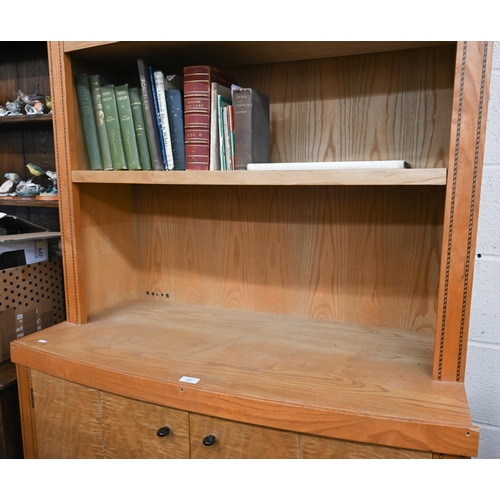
[{"x1": 75, "y1": 73, "x2": 103, "y2": 170}]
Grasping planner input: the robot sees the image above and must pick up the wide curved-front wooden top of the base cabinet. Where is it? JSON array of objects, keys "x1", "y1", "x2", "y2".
[{"x1": 11, "y1": 298, "x2": 479, "y2": 456}]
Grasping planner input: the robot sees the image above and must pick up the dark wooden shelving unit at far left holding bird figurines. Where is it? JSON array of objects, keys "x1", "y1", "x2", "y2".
[{"x1": 0, "y1": 42, "x2": 59, "y2": 231}]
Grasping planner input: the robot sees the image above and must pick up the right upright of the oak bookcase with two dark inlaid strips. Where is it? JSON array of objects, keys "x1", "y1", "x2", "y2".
[{"x1": 433, "y1": 42, "x2": 492, "y2": 382}]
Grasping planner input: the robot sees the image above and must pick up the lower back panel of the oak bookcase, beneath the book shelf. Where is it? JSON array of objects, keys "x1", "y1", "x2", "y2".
[{"x1": 133, "y1": 186, "x2": 444, "y2": 331}]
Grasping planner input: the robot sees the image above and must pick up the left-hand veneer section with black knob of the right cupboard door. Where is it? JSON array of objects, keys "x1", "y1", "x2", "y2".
[{"x1": 189, "y1": 414, "x2": 298, "y2": 458}]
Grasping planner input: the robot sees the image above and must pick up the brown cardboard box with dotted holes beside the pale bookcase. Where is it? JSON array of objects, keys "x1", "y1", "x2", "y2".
[{"x1": 0, "y1": 257, "x2": 66, "y2": 363}]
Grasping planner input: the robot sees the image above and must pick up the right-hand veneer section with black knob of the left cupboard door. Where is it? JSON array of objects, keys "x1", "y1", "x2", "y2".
[{"x1": 101, "y1": 392, "x2": 189, "y2": 458}]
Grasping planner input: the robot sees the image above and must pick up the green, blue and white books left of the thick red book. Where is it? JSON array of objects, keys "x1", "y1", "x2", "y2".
[{"x1": 75, "y1": 65, "x2": 186, "y2": 170}]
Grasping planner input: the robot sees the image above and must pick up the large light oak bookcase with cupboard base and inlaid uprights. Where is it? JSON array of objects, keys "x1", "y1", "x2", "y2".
[{"x1": 11, "y1": 42, "x2": 492, "y2": 458}]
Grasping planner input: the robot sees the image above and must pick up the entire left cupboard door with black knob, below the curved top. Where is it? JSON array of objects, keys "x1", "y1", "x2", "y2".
[{"x1": 31, "y1": 370, "x2": 189, "y2": 458}]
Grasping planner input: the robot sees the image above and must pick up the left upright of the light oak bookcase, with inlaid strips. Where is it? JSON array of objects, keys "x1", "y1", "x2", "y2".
[{"x1": 47, "y1": 42, "x2": 87, "y2": 323}]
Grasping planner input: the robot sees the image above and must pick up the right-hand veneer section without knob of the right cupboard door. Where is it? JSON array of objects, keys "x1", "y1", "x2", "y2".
[{"x1": 299, "y1": 434, "x2": 432, "y2": 459}]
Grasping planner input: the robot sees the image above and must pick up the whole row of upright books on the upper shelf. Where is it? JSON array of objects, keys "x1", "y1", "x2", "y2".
[{"x1": 75, "y1": 63, "x2": 270, "y2": 170}]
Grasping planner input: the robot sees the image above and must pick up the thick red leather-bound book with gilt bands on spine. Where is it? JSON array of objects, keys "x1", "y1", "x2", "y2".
[{"x1": 184, "y1": 66, "x2": 236, "y2": 170}]
